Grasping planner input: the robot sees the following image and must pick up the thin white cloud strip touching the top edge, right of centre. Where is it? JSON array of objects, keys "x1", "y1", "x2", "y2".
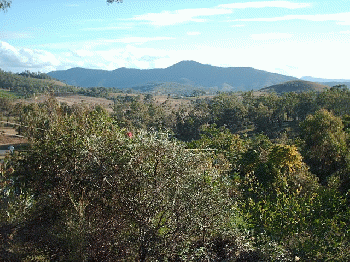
[{"x1": 218, "y1": 1, "x2": 311, "y2": 9}]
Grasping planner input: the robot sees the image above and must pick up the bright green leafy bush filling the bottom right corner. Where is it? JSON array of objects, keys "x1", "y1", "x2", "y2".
[{"x1": 244, "y1": 181, "x2": 350, "y2": 261}]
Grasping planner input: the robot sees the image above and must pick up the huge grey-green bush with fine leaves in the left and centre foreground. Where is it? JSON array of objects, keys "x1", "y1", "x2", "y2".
[{"x1": 2, "y1": 100, "x2": 246, "y2": 261}]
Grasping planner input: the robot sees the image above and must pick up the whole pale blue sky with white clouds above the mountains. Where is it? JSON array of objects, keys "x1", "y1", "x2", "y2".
[{"x1": 0, "y1": 0, "x2": 350, "y2": 79}]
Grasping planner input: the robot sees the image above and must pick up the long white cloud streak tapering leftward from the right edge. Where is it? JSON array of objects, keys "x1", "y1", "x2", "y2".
[{"x1": 233, "y1": 12, "x2": 350, "y2": 25}]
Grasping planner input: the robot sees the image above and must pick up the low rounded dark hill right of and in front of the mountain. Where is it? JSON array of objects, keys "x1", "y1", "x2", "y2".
[{"x1": 260, "y1": 80, "x2": 329, "y2": 94}]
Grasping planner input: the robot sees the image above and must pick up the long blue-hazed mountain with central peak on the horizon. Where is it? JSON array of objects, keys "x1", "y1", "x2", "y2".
[{"x1": 48, "y1": 61, "x2": 297, "y2": 91}]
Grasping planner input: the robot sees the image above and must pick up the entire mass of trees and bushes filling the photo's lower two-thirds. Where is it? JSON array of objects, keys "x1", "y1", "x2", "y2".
[{"x1": 0, "y1": 86, "x2": 350, "y2": 261}]
